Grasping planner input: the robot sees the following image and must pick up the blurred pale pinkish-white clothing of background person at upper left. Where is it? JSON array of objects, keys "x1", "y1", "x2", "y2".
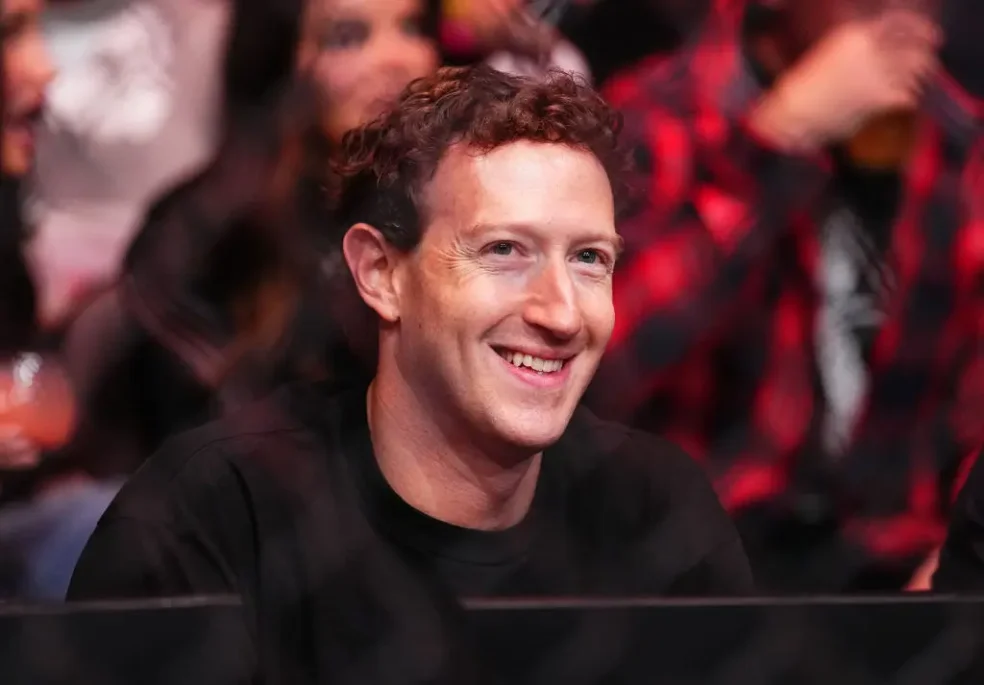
[{"x1": 28, "y1": 0, "x2": 231, "y2": 328}]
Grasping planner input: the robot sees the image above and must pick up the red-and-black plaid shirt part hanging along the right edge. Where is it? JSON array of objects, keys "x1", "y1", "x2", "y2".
[{"x1": 844, "y1": 79, "x2": 984, "y2": 557}]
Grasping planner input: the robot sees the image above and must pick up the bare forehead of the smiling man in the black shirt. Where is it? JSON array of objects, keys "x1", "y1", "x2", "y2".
[{"x1": 423, "y1": 141, "x2": 615, "y2": 242}]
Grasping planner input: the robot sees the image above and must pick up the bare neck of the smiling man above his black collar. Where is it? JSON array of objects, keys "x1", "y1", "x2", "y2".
[{"x1": 367, "y1": 363, "x2": 542, "y2": 530}]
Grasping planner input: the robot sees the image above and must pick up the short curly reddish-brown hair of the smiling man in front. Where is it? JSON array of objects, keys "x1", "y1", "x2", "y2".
[{"x1": 334, "y1": 65, "x2": 627, "y2": 251}]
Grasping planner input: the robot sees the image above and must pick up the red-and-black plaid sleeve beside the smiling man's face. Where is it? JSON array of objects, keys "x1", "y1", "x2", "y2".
[{"x1": 588, "y1": 60, "x2": 826, "y2": 421}]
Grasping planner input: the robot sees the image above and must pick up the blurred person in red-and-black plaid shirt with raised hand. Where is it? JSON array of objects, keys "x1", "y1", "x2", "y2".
[{"x1": 589, "y1": 0, "x2": 984, "y2": 591}]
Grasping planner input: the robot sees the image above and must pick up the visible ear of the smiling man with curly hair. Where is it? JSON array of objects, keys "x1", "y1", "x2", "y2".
[{"x1": 342, "y1": 223, "x2": 400, "y2": 323}]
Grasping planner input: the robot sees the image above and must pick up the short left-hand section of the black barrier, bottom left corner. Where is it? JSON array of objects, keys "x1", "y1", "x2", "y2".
[{"x1": 0, "y1": 598, "x2": 254, "y2": 685}]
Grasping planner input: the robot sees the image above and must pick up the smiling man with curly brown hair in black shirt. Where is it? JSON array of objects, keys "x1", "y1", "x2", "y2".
[{"x1": 70, "y1": 62, "x2": 749, "y2": 683}]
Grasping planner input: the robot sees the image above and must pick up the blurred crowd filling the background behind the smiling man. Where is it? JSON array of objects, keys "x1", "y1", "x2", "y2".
[{"x1": 0, "y1": 0, "x2": 984, "y2": 599}]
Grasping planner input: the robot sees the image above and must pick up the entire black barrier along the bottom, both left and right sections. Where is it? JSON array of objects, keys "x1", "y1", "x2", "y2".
[{"x1": 0, "y1": 597, "x2": 984, "y2": 685}]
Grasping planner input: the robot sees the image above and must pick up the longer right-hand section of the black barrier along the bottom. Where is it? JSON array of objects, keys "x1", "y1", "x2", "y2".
[{"x1": 468, "y1": 596, "x2": 984, "y2": 685}]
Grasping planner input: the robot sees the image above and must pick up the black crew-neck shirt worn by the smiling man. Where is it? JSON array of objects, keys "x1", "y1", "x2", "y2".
[{"x1": 69, "y1": 386, "x2": 751, "y2": 684}]
